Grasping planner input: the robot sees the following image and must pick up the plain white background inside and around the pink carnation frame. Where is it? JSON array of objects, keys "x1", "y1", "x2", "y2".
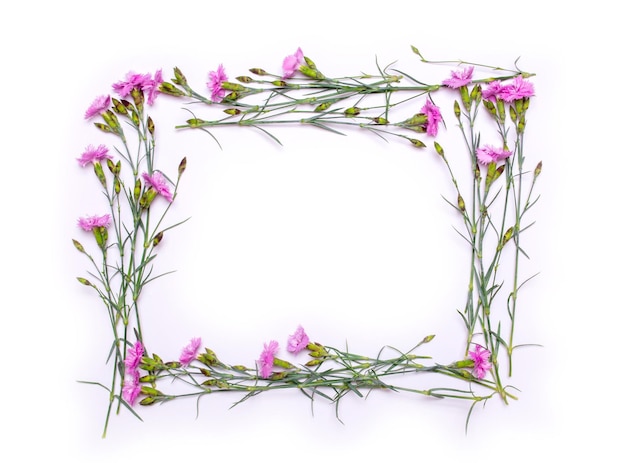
[{"x1": 0, "y1": 1, "x2": 624, "y2": 461}]
